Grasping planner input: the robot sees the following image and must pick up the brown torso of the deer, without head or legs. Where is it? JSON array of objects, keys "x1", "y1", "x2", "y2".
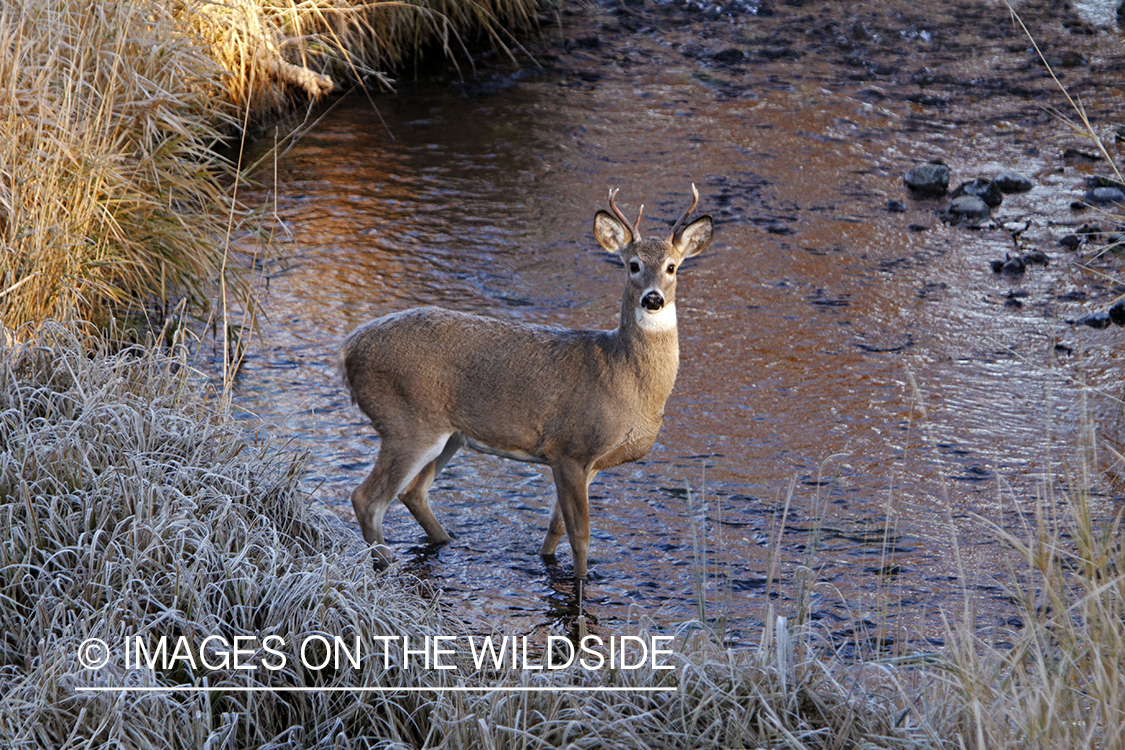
[{"x1": 343, "y1": 307, "x2": 675, "y2": 466}]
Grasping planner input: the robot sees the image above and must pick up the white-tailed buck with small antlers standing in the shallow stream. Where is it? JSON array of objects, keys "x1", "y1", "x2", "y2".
[{"x1": 342, "y1": 186, "x2": 714, "y2": 581}]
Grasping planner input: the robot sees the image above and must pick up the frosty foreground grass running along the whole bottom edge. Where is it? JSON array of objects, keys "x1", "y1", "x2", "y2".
[{"x1": 0, "y1": 326, "x2": 1125, "y2": 749}]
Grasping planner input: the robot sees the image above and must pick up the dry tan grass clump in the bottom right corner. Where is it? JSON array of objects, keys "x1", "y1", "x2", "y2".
[{"x1": 934, "y1": 489, "x2": 1125, "y2": 750}]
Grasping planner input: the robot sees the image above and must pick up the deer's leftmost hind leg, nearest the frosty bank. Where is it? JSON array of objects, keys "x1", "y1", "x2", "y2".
[{"x1": 352, "y1": 433, "x2": 451, "y2": 568}]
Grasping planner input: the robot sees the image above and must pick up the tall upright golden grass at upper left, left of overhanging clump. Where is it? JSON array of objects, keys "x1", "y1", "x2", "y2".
[{"x1": 0, "y1": 0, "x2": 247, "y2": 327}]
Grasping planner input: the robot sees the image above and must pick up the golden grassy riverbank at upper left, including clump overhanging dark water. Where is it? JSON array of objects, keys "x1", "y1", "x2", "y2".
[{"x1": 0, "y1": 0, "x2": 538, "y2": 329}]
